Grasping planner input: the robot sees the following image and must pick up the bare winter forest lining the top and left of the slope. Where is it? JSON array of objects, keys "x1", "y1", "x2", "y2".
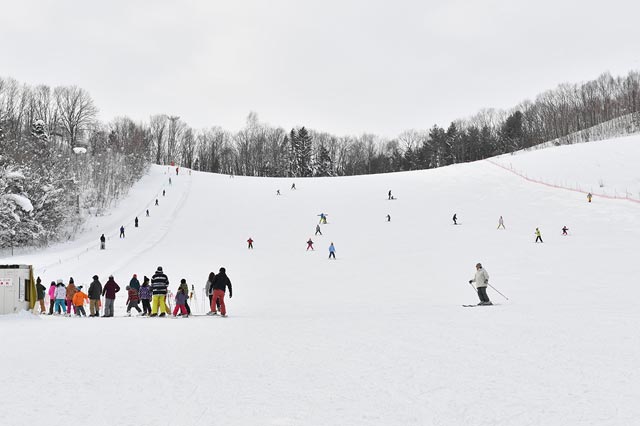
[{"x1": 0, "y1": 71, "x2": 640, "y2": 249}]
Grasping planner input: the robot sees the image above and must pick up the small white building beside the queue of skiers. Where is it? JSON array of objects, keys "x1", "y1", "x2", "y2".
[{"x1": 0, "y1": 265, "x2": 38, "y2": 314}]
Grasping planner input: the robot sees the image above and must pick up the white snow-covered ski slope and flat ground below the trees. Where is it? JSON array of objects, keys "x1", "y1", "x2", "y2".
[{"x1": 0, "y1": 137, "x2": 640, "y2": 426}]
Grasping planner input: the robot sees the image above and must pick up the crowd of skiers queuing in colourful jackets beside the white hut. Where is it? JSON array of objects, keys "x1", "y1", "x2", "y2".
[{"x1": 36, "y1": 266, "x2": 233, "y2": 318}]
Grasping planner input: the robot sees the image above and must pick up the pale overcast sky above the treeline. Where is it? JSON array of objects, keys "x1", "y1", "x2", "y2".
[{"x1": 0, "y1": 0, "x2": 640, "y2": 136}]
